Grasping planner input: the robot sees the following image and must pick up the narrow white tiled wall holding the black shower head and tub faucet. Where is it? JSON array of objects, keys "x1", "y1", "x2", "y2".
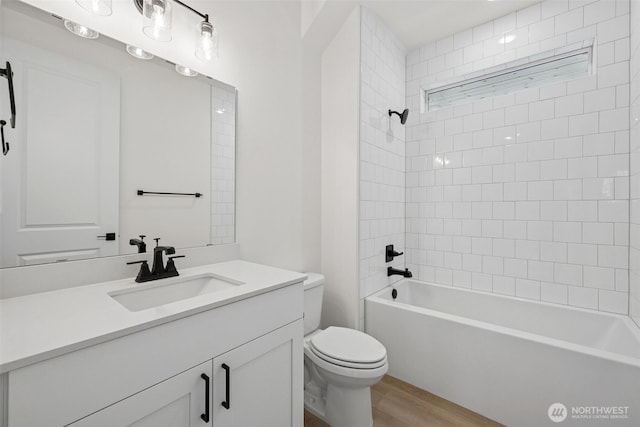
[{"x1": 359, "y1": 8, "x2": 404, "y2": 328}]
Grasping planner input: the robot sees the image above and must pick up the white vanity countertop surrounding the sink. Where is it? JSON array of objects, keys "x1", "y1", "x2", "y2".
[{"x1": 0, "y1": 260, "x2": 307, "y2": 374}]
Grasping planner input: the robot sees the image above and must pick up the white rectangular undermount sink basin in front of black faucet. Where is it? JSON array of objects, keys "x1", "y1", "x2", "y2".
[{"x1": 108, "y1": 273, "x2": 244, "y2": 311}]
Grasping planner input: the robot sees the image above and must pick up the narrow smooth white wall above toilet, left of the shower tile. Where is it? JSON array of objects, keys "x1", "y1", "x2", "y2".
[{"x1": 321, "y1": 8, "x2": 360, "y2": 328}]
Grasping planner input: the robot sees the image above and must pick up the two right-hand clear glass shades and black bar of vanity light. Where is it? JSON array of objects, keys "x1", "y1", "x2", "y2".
[{"x1": 133, "y1": 0, "x2": 218, "y2": 61}]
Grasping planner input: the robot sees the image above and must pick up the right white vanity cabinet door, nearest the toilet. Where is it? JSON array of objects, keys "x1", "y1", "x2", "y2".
[{"x1": 213, "y1": 320, "x2": 303, "y2": 427}]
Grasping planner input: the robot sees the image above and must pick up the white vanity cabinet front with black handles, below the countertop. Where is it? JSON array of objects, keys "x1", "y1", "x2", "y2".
[{"x1": 7, "y1": 284, "x2": 303, "y2": 427}]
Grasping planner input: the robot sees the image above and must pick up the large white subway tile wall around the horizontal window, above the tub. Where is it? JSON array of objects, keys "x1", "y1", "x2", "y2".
[{"x1": 404, "y1": 0, "x2": 640, "y2": 314}]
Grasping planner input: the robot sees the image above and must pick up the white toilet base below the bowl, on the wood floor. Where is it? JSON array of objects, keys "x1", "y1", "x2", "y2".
[{"x1": 325, "y1": 384, "x2": 373, "y2": 427}]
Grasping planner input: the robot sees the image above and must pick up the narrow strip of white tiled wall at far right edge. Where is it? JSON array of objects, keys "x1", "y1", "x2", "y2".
[{"x1": 628, "y1": 0, "x2": 640, "y2": 326}]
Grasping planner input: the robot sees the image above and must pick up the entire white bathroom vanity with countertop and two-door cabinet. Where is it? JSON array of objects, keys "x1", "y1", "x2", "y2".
[{"x1": 0, "y1": 260, "x2": 306, "y2": 427}]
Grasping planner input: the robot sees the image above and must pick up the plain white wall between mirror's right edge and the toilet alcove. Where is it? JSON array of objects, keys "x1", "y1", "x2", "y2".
[{"x1": 210, "y1": 1, "x2": 308, "y2": 270}]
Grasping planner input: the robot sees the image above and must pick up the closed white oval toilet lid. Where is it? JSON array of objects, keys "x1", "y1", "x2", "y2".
[{"x1": 311, "y1": 326, "x2": 387, "y2": 364}]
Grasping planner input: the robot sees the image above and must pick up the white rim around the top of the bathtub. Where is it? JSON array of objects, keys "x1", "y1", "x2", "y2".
[{"x1": 365, "y1": 278, "x2": 640, "y2": 368}]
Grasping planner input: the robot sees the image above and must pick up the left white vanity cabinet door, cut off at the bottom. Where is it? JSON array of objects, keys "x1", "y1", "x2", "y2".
[{"x1": 70, "y1": 361, "x2": 211, "y2": 427}]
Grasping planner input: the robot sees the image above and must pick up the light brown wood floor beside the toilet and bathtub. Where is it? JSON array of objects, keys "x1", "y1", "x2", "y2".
[{"x1": 304, "y1": 375, "x2": 502, "y2": 427}]
